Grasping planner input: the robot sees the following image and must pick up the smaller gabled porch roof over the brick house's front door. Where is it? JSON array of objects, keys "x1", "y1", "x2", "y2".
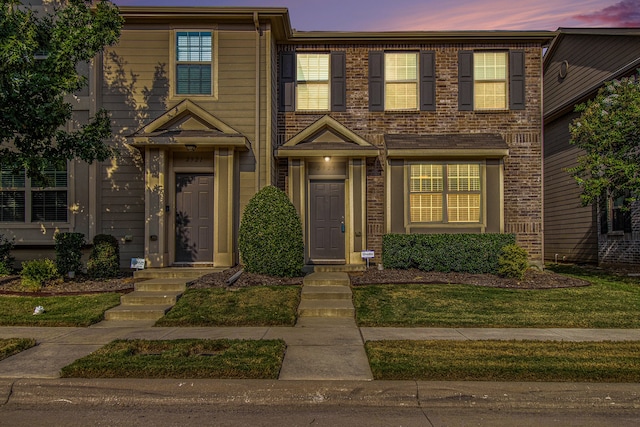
[{"x1": 277, "y1": 116, "x2": 378, "y2": 157}]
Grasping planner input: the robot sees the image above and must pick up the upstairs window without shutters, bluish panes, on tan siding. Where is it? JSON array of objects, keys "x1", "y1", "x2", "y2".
[{"x1": 176, "y1": 31, "x2": 212, "y2": 95}]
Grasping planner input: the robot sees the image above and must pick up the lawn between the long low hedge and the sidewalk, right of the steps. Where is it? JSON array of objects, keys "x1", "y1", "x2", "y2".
[{"x1": 353, "y1": 267, "x2": 640, "y2": 328}]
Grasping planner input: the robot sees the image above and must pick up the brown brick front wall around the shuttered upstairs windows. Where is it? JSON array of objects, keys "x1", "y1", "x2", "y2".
[{"x1": 278, "y1": 43, "x2": 543, "y2": 262}]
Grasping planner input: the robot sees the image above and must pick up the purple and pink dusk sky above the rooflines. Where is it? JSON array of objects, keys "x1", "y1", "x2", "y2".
[{"x1": 112, "y1": 0, "x2": 640, "y2": 31}]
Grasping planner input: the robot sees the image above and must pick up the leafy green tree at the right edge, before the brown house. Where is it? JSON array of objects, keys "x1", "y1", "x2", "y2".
[{"x1": 569, "y1": 76, "x2": 640, "y2": 209}]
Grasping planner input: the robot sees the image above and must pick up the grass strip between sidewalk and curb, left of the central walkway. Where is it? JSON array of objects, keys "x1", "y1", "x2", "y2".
[{"x1": 61, "y1": 339, "x2": 286, "y2": 379}]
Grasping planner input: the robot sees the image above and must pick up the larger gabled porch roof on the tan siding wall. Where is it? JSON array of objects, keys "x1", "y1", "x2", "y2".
[{"x1": 129, "y1": 99, "x2": 249, "y2": 150}]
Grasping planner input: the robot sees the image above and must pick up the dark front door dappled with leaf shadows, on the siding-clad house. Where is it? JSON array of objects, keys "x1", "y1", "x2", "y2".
[{"x1": 176, "y1": 173, "x2": 213, "y2": 263}]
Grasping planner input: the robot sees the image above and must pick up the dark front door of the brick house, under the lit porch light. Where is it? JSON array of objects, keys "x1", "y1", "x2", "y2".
[{"x1": 309, "y1": 181, "x2": 345, "y2": 264}]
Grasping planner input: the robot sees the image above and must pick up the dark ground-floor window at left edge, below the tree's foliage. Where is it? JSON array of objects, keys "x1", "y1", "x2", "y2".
[{"x1": 0, "y1": 162, "x2": 68, "y2": 222}]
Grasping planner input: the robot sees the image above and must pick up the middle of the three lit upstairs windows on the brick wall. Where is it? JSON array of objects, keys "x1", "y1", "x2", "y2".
[{"x1": 384, "y1": 53, "x2": 418, "y2": 110}]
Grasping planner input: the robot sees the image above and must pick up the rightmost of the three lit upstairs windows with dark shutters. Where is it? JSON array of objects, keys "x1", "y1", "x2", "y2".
[{"x1": 473, "y1": 52, "x2": 507, "y2": 110}]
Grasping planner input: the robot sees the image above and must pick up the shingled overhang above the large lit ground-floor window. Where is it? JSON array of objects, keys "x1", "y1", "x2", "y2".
[{"x1": 384, "y1": 134, "x2": 509, "y2": 159}]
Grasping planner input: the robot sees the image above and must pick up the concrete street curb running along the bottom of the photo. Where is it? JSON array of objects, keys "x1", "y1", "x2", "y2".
[{"x1": 0, "y1": 379, "x2": 640, "y2": 410}]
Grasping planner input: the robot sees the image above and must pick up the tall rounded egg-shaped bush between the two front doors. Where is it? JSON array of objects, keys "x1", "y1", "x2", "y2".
[{"x1": 239, "y1": 186, "x2": 304, "y2": 277}]
